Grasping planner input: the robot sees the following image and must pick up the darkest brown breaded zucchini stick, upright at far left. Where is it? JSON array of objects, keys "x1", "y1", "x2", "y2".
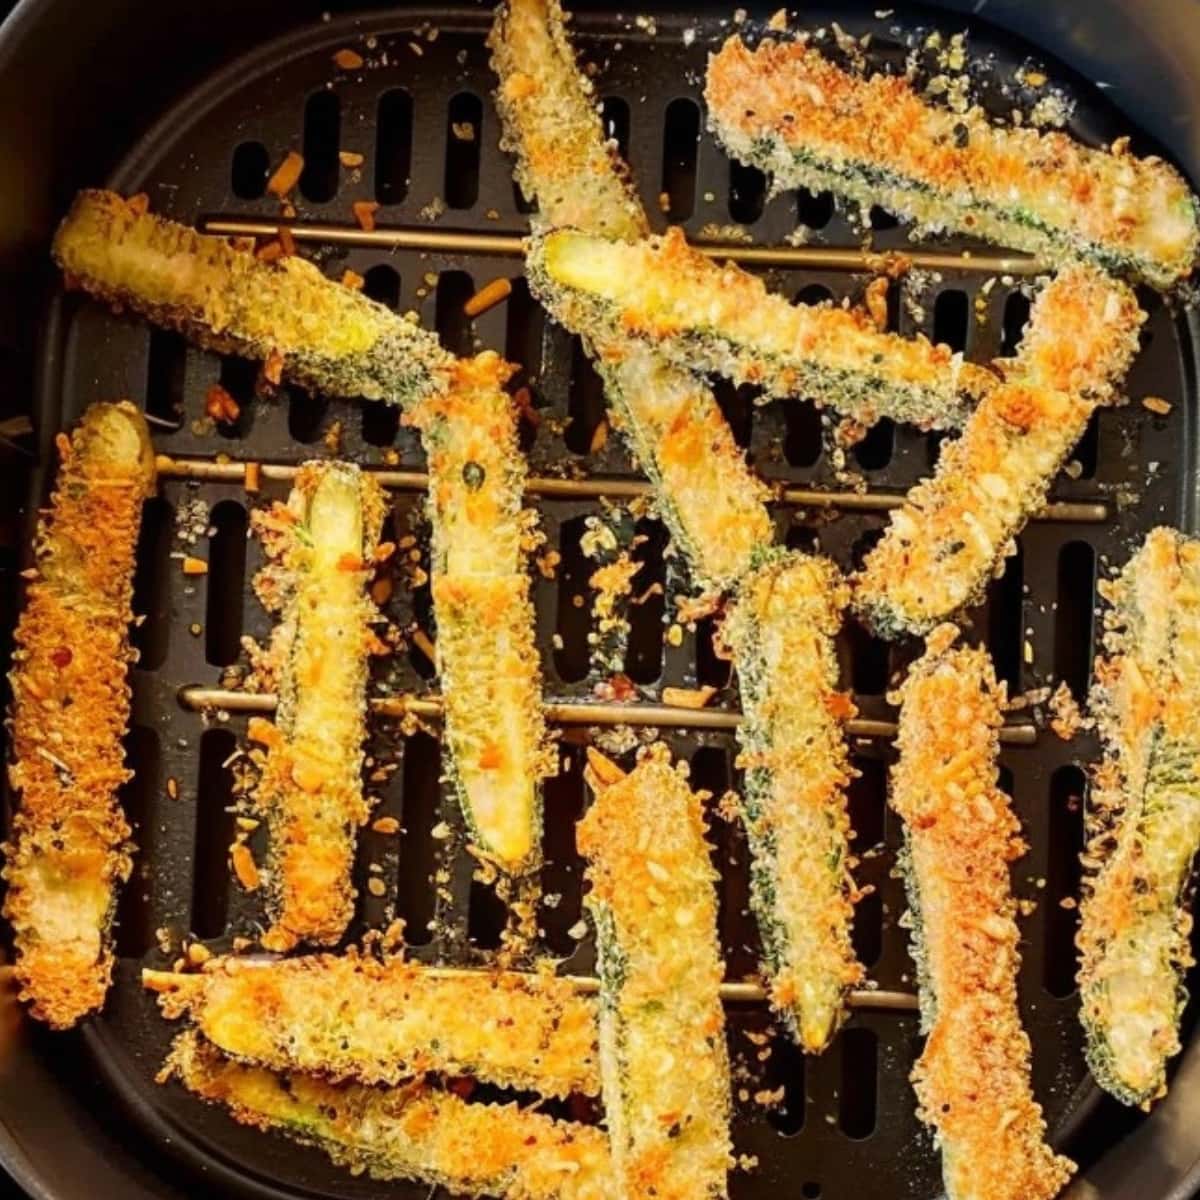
[{"x1": 4, "y1": 402, "x2": 155, "y2": 1028}]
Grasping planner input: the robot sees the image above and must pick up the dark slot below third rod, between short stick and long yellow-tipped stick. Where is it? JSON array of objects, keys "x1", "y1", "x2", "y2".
[{"x1": 396, "y1": 733, "x2": 442, "y2": 946}]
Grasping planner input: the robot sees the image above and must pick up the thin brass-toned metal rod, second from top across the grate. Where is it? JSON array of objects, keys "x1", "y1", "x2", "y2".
[{"x1": 158, "y1": 455, "x2": 1111, "y2": 524}]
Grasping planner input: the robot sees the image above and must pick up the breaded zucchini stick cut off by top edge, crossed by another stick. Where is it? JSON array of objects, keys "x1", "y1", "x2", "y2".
[{"x1": 488, "y1": 0, "x2": 774, "y2": 593}]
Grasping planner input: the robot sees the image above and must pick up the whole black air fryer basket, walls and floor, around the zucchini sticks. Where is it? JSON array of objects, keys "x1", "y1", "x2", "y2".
[{"x1": 0, "y1": 0, "x2": 1200, "y2": 1200}]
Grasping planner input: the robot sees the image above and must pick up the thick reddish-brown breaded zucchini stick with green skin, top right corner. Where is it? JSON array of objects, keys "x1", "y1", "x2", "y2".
[{"x1": 704, "y1": 36, "x2": 1200, "y2": 288}]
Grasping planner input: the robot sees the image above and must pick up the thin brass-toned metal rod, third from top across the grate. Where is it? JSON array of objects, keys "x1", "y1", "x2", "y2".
[{"x1": 179, "y1": 686, "x2": 1038, "y2": 746}]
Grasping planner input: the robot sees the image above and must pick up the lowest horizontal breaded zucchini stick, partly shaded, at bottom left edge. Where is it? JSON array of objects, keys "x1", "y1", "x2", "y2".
[{"x1": 161, "y1": 1031, "x2": 610, "y2": 1200}]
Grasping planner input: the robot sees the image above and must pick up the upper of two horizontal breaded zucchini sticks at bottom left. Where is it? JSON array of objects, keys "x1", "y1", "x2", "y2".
[{"x1": 142, "y1": 952, "x2": 600, "y2": 1096}]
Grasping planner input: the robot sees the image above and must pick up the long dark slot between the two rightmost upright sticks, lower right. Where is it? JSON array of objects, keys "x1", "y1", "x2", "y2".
[{"x1": 1042, "y1": 767, "x2": 1087, "y2": 996}]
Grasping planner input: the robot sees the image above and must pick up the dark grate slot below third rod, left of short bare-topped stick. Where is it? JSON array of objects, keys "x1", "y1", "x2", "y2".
[{"x1": 192, "y1": 730, "x2": 238, "y2": 938}]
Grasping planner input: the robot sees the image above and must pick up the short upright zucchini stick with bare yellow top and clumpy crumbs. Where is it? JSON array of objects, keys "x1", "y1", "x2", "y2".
[{"x1": 250, "y1": 462, "x2": 385, "y2": 950}]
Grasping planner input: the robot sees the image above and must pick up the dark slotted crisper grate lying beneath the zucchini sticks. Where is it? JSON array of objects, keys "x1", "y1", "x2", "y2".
[{"x1": 28, "y1": 5, "x2": 1194, "y2": 1200}]
